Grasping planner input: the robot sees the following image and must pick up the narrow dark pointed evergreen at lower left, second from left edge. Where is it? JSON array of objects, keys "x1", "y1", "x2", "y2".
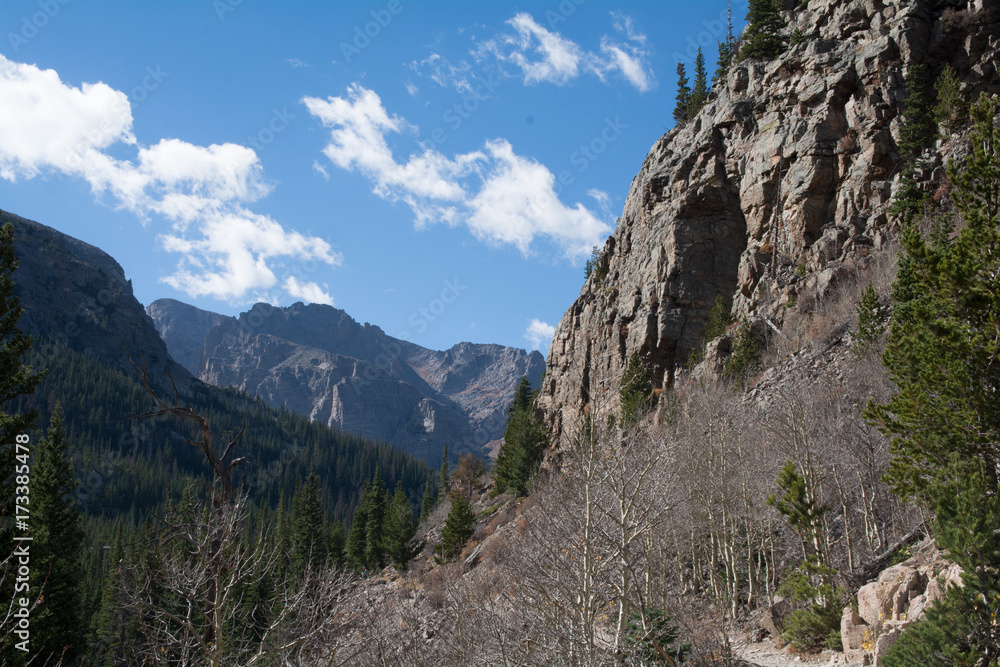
[{"x1": 31, "y1": 406, "x2": 85, "y2": 663}]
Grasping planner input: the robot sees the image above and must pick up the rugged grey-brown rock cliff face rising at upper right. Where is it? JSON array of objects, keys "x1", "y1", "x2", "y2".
[{"x1": 539, "y1": 0, "x2": 1000, "y2": 448}]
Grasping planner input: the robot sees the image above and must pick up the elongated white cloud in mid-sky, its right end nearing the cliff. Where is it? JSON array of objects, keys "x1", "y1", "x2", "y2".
[{"x1": 303, "y1": 84, "x2": 611, "y2": 258}]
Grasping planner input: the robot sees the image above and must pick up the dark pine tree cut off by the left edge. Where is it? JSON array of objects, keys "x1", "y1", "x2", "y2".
[{"x1": 0, "y1": 223, "x2": 43, "y2": 666}]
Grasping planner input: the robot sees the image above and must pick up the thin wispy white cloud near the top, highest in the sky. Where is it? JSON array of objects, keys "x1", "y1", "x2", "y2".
[{"x1": 474, "y1": 12, "x2": 656, "y2": 92}]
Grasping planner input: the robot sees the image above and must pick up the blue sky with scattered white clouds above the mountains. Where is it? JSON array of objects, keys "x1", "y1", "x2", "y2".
[{"x1": 0, "y1": 0, "x2": 746, "y2": 353}]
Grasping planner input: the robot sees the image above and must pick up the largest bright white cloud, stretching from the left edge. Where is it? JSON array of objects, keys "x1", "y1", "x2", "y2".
[{"x1": 0, "y1": 55, "x2": 341, "y2": 300}]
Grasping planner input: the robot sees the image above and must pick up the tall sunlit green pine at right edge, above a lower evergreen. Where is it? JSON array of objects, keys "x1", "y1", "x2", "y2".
[{"x1": 867, "y1": 97, "x2": 1000, "y2": 507}]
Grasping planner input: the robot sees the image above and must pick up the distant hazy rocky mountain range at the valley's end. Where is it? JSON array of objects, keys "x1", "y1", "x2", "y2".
[{"x1": 147, "y1": 299, "x2": 545, "y2": 463}]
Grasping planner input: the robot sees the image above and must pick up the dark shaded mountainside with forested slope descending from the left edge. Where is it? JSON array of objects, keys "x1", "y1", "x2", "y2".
[{"x1": 0, "y1": 212, "x2": 432, "y2": 524}]
